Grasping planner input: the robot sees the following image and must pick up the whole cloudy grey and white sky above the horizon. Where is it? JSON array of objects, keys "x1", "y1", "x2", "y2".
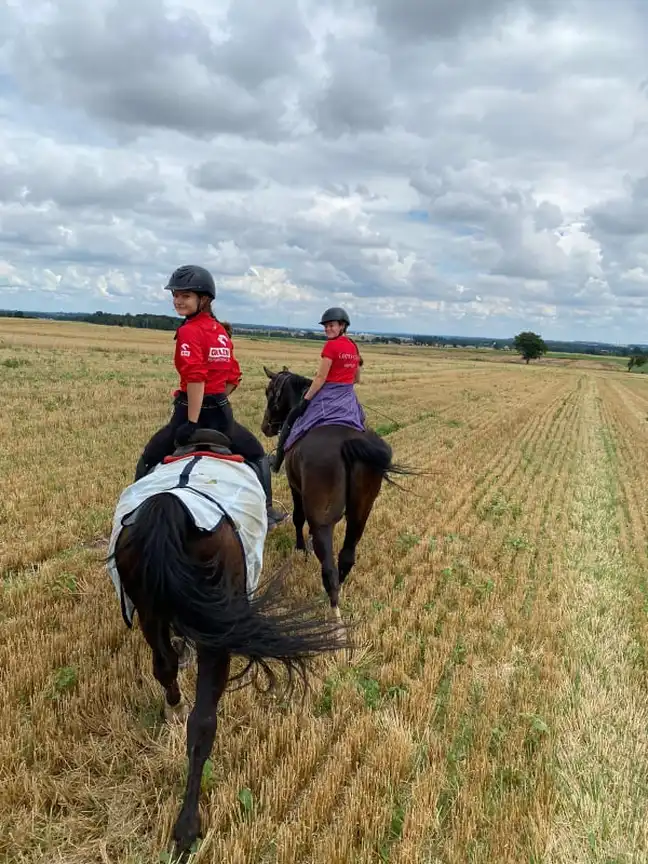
[{"x1": 0, "y1": 0, "x2": 648, "y2": 342}]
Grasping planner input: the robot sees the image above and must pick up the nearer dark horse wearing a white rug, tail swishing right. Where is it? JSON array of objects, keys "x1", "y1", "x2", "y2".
[{"x1": 106, "y1": 429, "x2": 349, "y2": 857}]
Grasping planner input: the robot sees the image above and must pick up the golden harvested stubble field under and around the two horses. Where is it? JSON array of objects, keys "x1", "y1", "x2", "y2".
[{"x1": 0, "y1": 320, "x2": 648, "y2": 864}]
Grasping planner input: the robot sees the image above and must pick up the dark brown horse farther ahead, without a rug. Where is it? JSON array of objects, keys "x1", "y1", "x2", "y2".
[{"x1": 261, "y1": 366, "x2": 416, "y2": 620}]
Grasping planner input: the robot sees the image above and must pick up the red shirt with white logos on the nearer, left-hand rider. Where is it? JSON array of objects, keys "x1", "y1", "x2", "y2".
[{"x1": 174, "y1": 312, "x2": 242, "y2": 395}]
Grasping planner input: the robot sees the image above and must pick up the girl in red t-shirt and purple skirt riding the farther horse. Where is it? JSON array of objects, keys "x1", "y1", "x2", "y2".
[{"x1": 272, "y1": 306, "x2": 365, "y2": 473}]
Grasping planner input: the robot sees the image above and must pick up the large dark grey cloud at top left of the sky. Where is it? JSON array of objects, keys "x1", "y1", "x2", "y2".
[{"x1": 8, "y1": 0, "x2": 290, "y2": 139}]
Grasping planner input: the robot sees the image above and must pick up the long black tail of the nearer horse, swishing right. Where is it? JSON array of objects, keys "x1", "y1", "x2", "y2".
[{"x1": 118, "y1": 493, "x2": 349, "y2": 687}]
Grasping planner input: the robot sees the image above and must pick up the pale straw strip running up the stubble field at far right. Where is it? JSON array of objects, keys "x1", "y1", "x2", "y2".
[{"x1": 543, "y1": 379, "x2": 648, "y2": 864}]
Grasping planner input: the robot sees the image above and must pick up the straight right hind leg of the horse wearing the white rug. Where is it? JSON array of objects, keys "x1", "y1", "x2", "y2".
[{"x1": 173, "y1": 647, "x2": 230, "y2": 852}]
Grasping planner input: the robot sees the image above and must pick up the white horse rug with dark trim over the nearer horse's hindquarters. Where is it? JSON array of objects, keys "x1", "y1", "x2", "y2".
[{"x1": 107, "y1": 453, "x2": 268, "y2": 627}]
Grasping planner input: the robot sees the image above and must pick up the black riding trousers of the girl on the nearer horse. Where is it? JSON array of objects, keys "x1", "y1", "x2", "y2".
[{"x1": 136, "y1": 394, "x2": 265, "y2": 479}]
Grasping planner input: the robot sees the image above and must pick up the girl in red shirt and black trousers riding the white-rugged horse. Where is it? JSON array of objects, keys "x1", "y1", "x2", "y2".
[{"x1": 135, "y1": 265, "x2": 288, "y2": 529}]
